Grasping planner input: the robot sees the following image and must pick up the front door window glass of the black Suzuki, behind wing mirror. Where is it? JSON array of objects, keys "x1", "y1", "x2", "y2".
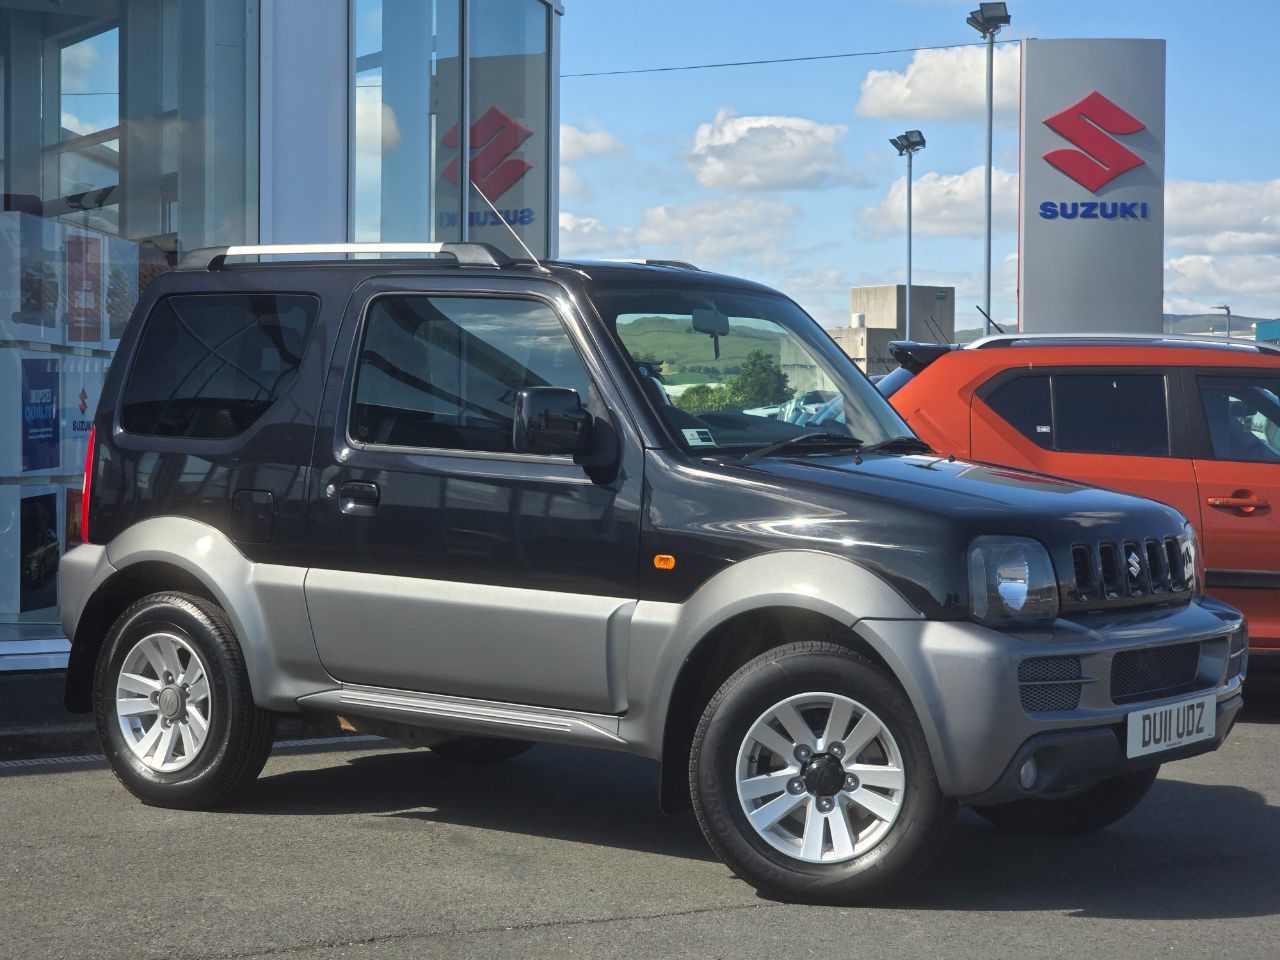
[{"x1": 349, "y1": 294, "x2": 589, "y2": 453}]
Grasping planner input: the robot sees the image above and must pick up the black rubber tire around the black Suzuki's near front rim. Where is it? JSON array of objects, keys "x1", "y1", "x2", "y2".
[{"x1": 689, "y1": 641, "x2": 956, "y2": 904}]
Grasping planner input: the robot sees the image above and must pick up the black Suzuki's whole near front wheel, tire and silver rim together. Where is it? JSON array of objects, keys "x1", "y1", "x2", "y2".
[{"x1": 689, "y1": 643, "x2": 956, "y2": 905}]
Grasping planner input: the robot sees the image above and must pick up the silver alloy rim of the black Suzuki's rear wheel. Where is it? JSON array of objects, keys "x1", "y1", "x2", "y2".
[{"x1": 115, "y1": 632, "x2": 214, "y2": 773}]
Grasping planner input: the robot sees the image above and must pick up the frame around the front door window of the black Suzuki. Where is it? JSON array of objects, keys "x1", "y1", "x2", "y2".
[{"x1": 339, "y1": 287, "x2": 604, "y2": 465}]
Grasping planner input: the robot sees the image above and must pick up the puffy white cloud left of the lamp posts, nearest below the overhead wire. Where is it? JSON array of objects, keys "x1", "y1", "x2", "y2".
[{"x1": 687, "y1": 108, "x2": 865, "y2": 189}]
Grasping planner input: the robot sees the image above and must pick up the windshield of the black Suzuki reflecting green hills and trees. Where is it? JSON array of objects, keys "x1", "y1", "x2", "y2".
[{"x1": 594, "y1": 287, "x2": 911, "y2": 453}]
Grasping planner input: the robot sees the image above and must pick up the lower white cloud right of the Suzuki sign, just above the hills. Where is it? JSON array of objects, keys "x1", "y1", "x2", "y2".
[{"x1": 1165, "y1": 253, "x2": 1280, "y2": 317}]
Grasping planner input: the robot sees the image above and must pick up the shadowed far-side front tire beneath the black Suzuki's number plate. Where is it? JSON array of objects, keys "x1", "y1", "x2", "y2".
[{"x1": 973, "y1": 767, "x2": 1160, "y2": 837}]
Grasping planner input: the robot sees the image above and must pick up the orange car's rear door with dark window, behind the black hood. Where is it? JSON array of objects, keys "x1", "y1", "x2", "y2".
[{"x1": 970, "y1": 366, "x2": 1201, "y2": 524}]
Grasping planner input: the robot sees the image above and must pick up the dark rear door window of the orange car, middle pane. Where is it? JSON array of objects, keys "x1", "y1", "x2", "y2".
[{"x1": 1053, "y1": 374, "x2": 1169, "y2": 457}]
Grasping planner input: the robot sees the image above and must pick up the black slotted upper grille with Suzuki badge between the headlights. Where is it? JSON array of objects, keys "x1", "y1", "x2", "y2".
[{"x1": 1065, "y1": 536, "x2": 1190, "y2": 604}]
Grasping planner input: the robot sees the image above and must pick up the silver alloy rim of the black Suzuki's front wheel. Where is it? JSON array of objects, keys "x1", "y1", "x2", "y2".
[{"x1": 737, "y1": 692, "x2": 906, "y2": 863}]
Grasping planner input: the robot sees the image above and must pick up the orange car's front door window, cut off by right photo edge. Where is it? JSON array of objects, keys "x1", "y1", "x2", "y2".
[{"x1": 1196, "y1": 376, "x2": 1280, "y2": 463}]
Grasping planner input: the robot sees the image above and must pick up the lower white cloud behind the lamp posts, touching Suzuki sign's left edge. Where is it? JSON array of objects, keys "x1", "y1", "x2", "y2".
[{"x1": 859, "y1": 166, "x2": 1018, "y2": 237}]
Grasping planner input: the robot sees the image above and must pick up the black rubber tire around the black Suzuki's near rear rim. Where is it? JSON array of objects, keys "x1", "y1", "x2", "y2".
[{"x1": 93, "y1": 593, "x2": 275, "y2": 810}]
